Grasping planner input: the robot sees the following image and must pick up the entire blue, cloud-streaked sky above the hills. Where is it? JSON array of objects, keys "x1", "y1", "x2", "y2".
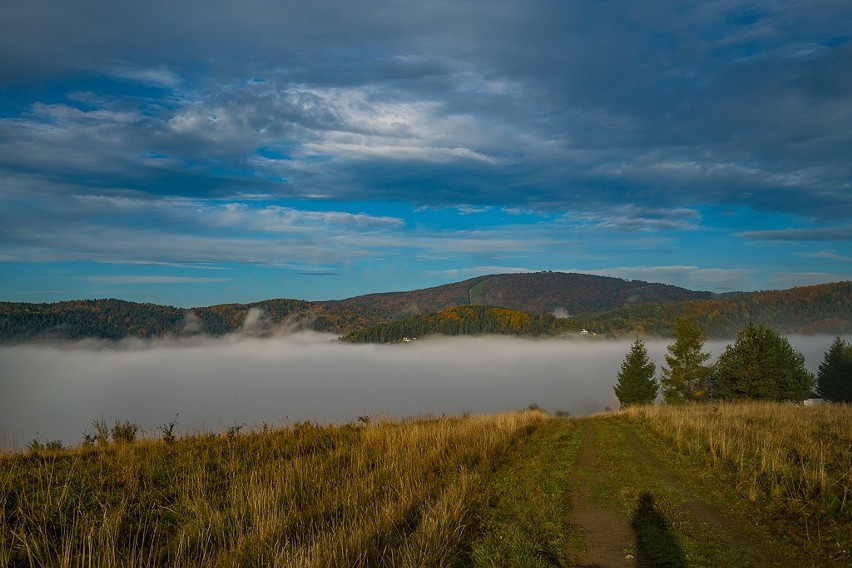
[{"x1": 0, "y1": 0, "x2": 852, "y2": 306}]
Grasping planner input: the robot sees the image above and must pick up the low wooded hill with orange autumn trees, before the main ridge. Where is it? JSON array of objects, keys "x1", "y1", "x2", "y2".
[{"x1": 343, "y1": 306, "x2": 565, "y2": 343}]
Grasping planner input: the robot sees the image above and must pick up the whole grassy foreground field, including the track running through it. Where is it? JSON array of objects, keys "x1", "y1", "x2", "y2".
[{"x1": 0, "y1": 404, "x2": 852, "y2": 567}]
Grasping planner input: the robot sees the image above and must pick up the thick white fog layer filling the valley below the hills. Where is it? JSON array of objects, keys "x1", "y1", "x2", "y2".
[{"x1": 0, "y1": 333, "x2": 844, "y2": 448}]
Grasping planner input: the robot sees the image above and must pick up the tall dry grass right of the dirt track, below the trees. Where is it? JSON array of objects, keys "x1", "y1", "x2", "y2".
[{"x1": 621, "y1": 402, "x2": 852, "y2": 558}]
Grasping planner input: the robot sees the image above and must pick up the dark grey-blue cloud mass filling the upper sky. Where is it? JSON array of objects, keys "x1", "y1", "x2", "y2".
[{"x1": 0, "y1": 1, "x2": 852, "y2": 218}]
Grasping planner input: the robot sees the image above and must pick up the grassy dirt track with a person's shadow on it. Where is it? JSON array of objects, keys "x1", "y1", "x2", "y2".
[{"x1": 565, "y1": 418, "x2": 819, "y2": 567}]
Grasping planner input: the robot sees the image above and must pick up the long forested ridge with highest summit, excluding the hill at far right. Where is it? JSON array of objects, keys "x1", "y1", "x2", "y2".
[{"x1": 0, "y1": 272, "x2": 710, "y2": 342}]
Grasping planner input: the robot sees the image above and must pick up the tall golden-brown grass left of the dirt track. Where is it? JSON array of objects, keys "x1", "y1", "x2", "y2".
[{"x1": 0, "y1": 411, "x2": 546, "y2": 567}]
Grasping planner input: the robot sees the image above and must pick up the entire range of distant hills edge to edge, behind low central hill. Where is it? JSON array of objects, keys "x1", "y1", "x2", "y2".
[{"x1": 0, "y1": 272, "x2": 852, "y2": 343}]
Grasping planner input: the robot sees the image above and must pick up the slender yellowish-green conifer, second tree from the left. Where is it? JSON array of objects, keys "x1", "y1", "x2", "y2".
[{"x1": 660, "y1": 316, "x2": 711, "y2": 404}]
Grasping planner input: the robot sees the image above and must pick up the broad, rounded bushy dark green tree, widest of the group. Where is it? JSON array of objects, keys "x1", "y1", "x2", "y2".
[{"x1": 714, "y1": 323, "x2": 814, "y2": 401}]
